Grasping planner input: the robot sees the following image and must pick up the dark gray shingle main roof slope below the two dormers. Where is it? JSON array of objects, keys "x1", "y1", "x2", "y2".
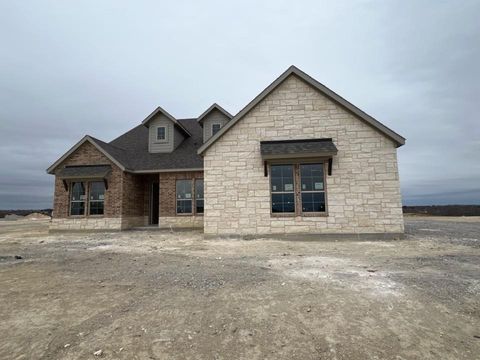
[{"x1": 107, "y1": 119, "x2": 203, "y2": 171}]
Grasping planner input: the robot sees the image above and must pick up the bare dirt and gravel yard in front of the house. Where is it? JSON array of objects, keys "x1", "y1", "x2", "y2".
[{"x1": 0, "y1": 217, "x2": 480, "y2": 360}]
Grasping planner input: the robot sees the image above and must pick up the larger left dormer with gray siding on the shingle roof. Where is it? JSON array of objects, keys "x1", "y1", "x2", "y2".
[{"x1": 142, "y1": 106, "x2": 191, "y2": 153}]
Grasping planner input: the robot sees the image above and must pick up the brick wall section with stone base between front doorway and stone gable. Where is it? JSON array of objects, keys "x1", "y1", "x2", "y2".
[{"x1": 158, "y1": 171, "x2": 203, "y2": 228}]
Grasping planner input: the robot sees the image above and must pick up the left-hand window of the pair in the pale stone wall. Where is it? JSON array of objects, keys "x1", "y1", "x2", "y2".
[{"x1": 271, "y1": 165, "x2": 295, "y2": 213}]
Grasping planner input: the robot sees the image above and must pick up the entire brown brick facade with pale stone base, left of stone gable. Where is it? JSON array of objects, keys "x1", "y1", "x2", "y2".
[{"x1": 51, "y1": 142, "x2": 203, "y2": 230}]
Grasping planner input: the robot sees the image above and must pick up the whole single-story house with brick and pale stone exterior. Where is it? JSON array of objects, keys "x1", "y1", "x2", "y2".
[{"x1": 47, "y1": 66, "x2": 405, "y2": 237}]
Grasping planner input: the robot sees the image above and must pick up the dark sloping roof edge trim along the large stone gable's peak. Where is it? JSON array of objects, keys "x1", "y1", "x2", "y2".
[{"x1": 198, "y1": 65, "x2": 405, "y2": 154}]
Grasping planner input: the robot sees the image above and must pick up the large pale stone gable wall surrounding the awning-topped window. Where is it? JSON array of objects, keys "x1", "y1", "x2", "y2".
[{"x1": 204, "y1": 75, "x2": 404, "y2": 235}]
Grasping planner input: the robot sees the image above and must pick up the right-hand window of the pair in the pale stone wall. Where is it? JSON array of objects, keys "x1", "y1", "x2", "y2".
[{"x1": 300, "y1": 164, "x2": 325, "y2": 212}]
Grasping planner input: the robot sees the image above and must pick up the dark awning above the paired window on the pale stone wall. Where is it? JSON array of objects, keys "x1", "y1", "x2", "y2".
[{"x1": 260, "y1": 139, "x2": 337, "y2": 160}]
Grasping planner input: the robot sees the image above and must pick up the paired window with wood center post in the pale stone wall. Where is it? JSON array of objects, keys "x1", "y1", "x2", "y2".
[{"x1": 270, "y1": 163, "x2": 326, "y2": 215}]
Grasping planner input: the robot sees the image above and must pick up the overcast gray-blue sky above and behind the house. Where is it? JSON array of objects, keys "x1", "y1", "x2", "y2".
[{"x1": 0, "y1": 0, "x2": 480, "y2": 209}]
